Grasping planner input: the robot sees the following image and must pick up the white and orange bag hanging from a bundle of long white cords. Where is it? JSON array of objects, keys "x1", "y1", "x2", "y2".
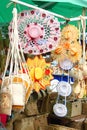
[{"x1": 2, "y1": 8, "x2": 32, "y2": 110}]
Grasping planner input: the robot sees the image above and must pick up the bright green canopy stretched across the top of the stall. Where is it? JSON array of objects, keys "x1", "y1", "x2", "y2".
[{"x1": 0, "y1": 0, "x2": 87, "y2": 38}]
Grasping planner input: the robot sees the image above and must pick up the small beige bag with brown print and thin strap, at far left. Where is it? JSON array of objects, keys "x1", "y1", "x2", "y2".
[{"x1": 0, "y1": 45, "x2": 12, "y2": 115}]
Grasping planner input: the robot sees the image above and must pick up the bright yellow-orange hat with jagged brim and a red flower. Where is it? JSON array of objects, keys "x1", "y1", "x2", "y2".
[{"x1": 27, "y1": 56, "x2": 53, "y2": 92}]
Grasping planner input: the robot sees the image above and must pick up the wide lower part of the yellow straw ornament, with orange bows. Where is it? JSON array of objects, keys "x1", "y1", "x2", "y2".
[{"x1": 51, "y1": 39, "x2": 82, "y2": 63}]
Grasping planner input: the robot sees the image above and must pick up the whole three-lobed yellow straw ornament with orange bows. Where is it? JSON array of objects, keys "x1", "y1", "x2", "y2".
[{"x1": 52, "y1": 24, "x2": 82, "y2": 63}]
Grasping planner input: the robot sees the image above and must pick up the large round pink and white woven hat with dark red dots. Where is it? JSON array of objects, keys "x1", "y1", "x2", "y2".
[{"x1": 9, "y1": 10, "x2": 60, "y2": 55}]
